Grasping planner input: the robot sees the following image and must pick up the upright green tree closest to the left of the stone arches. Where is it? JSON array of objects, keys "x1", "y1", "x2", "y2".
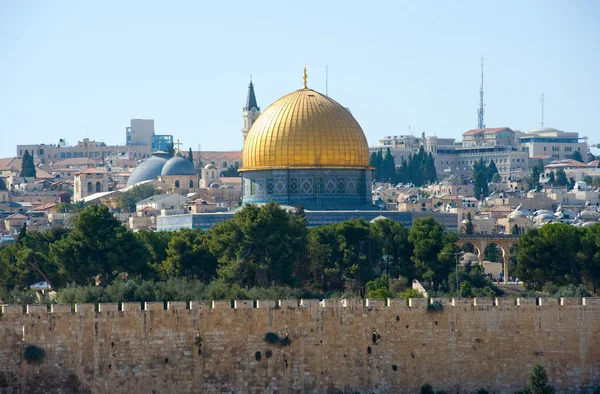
[{"x1": 408, "y1": 217, "x2": 458, "y2": 290}]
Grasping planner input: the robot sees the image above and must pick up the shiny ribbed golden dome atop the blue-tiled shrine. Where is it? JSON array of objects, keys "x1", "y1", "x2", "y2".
[{"x1": 242, "y1": 89, "x2": 369, "y2": 170}]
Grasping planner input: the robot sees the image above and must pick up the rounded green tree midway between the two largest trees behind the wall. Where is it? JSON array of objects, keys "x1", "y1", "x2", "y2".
[{"x1": 158, "y1": 229, "x2": 217, "y2": 283}]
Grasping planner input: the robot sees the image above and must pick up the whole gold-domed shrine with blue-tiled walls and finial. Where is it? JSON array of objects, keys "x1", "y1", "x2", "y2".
[{"x1": 240, "y1": 67, "x2": 373, "y2": 210}]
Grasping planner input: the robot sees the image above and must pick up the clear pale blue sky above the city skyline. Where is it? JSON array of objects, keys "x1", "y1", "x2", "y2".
[{"x1": 0, "y1": 0, "x2": 600, "y2": 157}]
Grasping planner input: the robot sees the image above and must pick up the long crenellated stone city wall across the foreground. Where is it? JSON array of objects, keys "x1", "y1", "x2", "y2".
[{"x1": 0, "y1": 298, "x2": 600, "y2": 394}]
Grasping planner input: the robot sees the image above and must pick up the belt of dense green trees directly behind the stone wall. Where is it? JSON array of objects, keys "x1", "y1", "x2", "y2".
[{"x1": 10, "y1": 203, "x2": 600, "y2": 302}]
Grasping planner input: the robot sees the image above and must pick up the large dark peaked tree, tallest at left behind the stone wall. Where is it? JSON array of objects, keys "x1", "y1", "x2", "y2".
[{"x1": 50, "y1": 205, "x2": 150, "y2": 284}]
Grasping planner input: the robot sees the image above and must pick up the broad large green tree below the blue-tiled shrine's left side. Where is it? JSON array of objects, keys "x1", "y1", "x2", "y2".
[{"x1": 207, "y1": 203, "x2": 307, "y2": 286}]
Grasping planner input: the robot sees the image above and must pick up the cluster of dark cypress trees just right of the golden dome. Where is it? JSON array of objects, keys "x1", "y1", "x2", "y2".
[{"x1": 370, "y1": 147, "x2": 437, "y2": 186}]
